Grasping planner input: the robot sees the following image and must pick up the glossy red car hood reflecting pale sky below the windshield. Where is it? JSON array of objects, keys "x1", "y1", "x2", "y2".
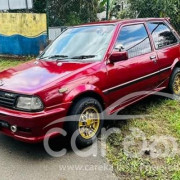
[{"x1": 0, "y1": 60, "x2": 89, "y2": 94}]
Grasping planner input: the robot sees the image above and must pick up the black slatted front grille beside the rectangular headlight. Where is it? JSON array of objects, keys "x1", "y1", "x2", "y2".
[{"x1": 0, "y1": 91, "x2": 17, "y2": 108}]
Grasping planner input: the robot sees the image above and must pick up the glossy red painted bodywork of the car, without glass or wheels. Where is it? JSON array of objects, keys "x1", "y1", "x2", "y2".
[{"x1": 0, "y1": 18, "x2": 180, "y2": 143}]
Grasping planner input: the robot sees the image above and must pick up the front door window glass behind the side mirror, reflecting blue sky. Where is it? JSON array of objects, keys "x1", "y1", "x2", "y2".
[{"x1": 115, "y1": 24, "x2": 152, "y2": 58}]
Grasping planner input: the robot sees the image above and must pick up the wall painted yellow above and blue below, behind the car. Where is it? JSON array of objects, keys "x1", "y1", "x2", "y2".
[{"x1": 0, "y1": 13, "x2": 47, "y2": 55}]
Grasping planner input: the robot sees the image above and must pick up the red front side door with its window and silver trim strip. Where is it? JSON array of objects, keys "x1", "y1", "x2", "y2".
[{"x1": 104, "y1": 23, "x2": 159, "y2": 106}]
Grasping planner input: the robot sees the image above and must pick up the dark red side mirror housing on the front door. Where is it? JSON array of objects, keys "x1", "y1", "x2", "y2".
[{"x1": 109, "y1": 51, "x2": 128, "y2": 63}]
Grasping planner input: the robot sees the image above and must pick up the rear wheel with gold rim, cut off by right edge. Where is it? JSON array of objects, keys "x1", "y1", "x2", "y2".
[{"x1": 168, "y1": 68, "x2": 180, "y2": 96}]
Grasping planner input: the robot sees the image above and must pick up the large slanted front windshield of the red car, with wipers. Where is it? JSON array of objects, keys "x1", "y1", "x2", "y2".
[{"x1": 39, "y1": 25, "x2": 114, "y2": 61}]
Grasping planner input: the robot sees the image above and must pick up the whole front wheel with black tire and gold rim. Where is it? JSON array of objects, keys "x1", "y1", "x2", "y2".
[{"x1": 66, "y1": 97, "x2": 104, "y2": 147}]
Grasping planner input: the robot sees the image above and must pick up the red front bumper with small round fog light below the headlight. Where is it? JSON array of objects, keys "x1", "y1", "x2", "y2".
[{"x1": 0, "y1": 103, "x2": 71, "y2": 143}]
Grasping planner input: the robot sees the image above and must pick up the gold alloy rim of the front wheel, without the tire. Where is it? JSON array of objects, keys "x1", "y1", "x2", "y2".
[{"x1": 79, "y1": 107, "x2": 100, "y2": 139}]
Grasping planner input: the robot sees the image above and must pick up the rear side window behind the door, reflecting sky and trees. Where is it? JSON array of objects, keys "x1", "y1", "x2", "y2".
[{"x1": 148, "y1": 22, "x2": 178, "y2": 49}]
